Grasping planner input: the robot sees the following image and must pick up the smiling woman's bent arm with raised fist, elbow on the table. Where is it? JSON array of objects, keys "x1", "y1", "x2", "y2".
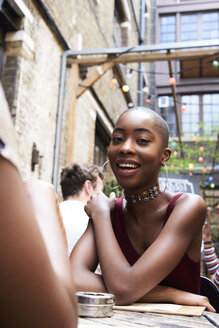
[{"x1": 86, "y1": 194, "x2": 206, "y2": 304}]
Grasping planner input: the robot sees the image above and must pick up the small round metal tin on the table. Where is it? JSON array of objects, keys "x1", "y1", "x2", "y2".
[{"x1": 76, "y1": 292, "x2": 115, "y2": 318}]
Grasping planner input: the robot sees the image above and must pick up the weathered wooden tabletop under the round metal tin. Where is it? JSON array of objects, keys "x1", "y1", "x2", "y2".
[{"x1": 78, "y1": 310, "x2": 219, "y2": 328}]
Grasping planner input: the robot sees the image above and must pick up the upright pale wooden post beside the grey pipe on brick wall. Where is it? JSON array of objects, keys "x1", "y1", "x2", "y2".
[{"x1": 65, "y1": 64, "x2": 79, "y2": 165}]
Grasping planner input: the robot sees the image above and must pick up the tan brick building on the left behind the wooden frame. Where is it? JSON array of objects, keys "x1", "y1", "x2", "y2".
[{"x1": 0, "y1": 0, "x2": 154, "y2": 193}]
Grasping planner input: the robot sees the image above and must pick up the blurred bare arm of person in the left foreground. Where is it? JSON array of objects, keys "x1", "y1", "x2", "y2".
[{"x1": 0, "y1": 156, "x2": 77, "y2": 328}]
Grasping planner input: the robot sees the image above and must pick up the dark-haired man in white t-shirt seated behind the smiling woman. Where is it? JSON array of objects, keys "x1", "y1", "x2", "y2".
[{"x1": 59, "y1": 164, "x2": 104, "y2": 255}]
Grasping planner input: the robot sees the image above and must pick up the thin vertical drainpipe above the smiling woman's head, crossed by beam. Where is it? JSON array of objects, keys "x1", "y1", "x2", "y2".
[{"x1": 138, "y1": 0, "x2": 145, "y2": 106}]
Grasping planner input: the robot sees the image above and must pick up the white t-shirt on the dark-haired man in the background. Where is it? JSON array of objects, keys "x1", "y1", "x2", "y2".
[{"x1": 60, "y1": 200, "x2": 89, "y2": 255}]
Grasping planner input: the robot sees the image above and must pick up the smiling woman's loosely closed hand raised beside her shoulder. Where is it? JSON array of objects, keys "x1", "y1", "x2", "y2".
[{"x1": 84, "y1": 192, "x2": 115, "y2": 221}]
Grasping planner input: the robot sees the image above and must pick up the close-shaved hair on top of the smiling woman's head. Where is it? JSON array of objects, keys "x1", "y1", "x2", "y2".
[{"x1": 119, "y1": 106, "x2": 169, "y2": 148}]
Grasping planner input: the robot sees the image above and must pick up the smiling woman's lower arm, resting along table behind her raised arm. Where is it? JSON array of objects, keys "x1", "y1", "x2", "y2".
[{"x1": 70, "y1": 193, "x2": 214, "y2": 312}]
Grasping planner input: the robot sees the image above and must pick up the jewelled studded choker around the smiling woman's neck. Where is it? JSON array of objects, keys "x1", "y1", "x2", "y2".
[{"x1": 124, "y1": 185, "x2": 160, "y2": 204}]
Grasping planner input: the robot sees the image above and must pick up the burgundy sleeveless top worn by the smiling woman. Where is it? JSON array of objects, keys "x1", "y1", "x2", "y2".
[{"x1": 113, "y1": 194, "x2": 200, "y2": 294}]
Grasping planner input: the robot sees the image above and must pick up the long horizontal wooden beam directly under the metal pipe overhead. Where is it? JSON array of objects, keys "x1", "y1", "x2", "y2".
[{"x1": 68, "y1": 48, "x2": 219, "y2": 66}]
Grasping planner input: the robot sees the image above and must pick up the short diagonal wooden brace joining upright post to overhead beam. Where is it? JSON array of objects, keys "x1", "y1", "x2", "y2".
[{"x1": 76, "y1": 62, "x2": 115, "y2": 98}]
